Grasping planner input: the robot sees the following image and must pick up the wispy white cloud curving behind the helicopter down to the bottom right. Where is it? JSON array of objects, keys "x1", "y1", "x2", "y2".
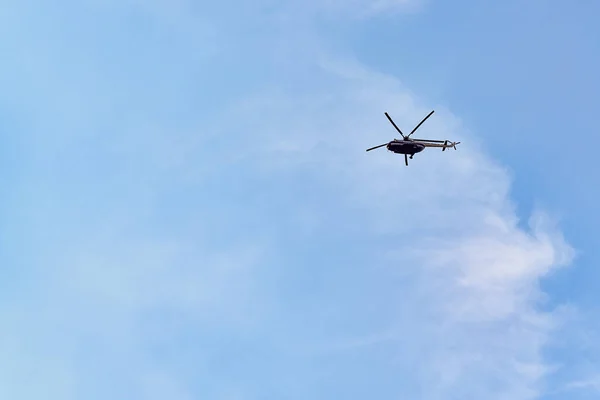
[{"x1": 195, "y1": 55, "x2": 573, "y2": 399}]
